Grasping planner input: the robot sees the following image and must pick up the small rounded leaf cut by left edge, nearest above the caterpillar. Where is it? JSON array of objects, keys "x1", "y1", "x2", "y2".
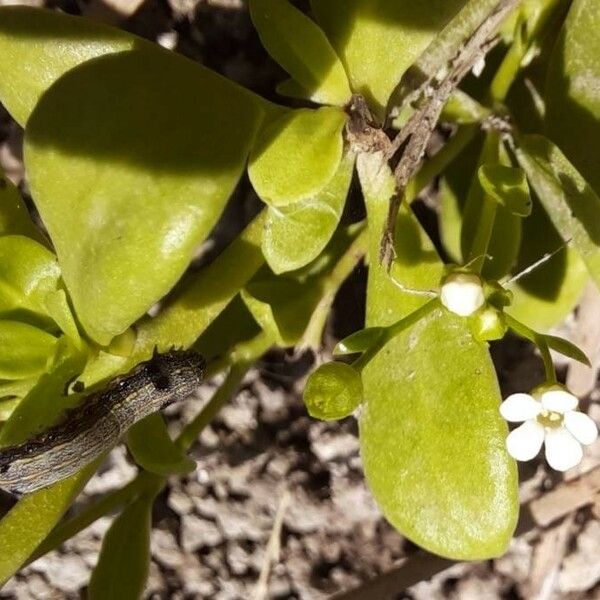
[{"x1": 0, "y1": 321, "x2": 56, "y2": 379}]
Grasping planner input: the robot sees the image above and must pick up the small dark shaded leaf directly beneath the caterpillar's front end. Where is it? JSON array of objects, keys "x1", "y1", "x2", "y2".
[{"x1": 127, "y1": 413, "x2": 196, "y2": 475}]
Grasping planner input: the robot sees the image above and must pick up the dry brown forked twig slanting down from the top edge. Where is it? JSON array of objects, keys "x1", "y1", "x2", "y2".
[{"x1": 379, "y1": 0, "x2": 521, "y2": 270}]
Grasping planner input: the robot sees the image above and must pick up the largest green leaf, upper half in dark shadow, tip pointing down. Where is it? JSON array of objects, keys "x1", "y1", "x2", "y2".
[{"x1": 25, "y1": 47, "x2": 262, "y2": 344}]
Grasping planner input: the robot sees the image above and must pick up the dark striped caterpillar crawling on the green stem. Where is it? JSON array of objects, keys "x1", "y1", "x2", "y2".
[{"x1": 0, "y1": 351, "x2": 205, "y2": 495}]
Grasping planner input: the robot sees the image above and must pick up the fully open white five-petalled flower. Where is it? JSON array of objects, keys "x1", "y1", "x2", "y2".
[{"x1": 500, "y1": 388, "x2": 598, "y2": 471}]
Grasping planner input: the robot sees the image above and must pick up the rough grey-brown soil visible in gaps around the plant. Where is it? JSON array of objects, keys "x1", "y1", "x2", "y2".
[{"x1": 0, "y1": 0, "x2": 600, "y2": 600}]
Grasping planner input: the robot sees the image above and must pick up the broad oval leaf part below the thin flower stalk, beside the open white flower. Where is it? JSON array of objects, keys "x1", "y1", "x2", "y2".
[{"x1": 359, "y1": 307, "x2": 518, "y2": 560}]
